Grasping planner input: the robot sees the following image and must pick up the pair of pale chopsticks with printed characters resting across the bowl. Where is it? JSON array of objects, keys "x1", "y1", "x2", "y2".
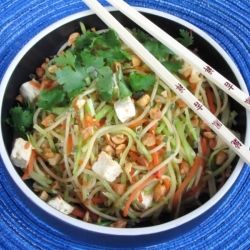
[{"x1": 83, "y1": 0, "x2": 250, "y2": 164}]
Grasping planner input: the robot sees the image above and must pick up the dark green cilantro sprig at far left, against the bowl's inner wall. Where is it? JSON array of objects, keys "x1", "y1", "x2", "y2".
[{"x1": 7, "y1": 106, "x2": 33, "y2": 137}]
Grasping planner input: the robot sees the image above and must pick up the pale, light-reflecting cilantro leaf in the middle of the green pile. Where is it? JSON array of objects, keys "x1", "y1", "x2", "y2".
[{"x1": 56, "y1": 66, "x2": 87, "y2": 97}]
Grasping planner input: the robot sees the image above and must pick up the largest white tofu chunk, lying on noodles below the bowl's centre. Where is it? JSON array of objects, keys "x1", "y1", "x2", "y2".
[{"x1": 92, "y1": 151, "x2": 122, "y2": 182}]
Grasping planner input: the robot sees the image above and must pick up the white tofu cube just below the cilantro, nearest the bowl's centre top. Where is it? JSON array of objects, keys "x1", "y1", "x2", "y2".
[{"x1": 114, "y1": 97, "x2": 136, "y2": 122}]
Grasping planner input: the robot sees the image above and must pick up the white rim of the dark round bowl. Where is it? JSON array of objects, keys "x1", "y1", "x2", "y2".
[{"x1": 0, "y1": 7, "x2": 250, "y2": 236}]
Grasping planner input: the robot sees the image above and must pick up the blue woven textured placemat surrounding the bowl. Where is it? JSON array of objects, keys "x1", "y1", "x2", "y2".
[{"x1": 0, "y1": 0, "x2": 250, "y2": 250}]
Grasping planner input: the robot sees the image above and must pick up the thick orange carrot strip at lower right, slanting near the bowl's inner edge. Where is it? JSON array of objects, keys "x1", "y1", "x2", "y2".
[{"x1": 173, "y1": 156, "x2": 203, "y2": 208}]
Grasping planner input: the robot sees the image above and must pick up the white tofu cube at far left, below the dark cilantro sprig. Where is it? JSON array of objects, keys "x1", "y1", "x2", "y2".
[{"x1": 10, "y1": 138, "x2": 32, "y2": 169}]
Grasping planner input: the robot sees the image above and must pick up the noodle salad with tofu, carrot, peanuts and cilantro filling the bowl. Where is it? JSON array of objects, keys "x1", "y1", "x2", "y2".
[{"x1": 8, "y1": 24, "x2": 240, "y2": 227}]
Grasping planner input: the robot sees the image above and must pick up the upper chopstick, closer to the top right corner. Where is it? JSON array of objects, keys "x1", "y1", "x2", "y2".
[{"x1": 107, "y1": 0, "x2": 250, "y2": 110}]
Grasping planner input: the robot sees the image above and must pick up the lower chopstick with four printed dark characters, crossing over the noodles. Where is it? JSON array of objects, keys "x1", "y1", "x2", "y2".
[{"x1": 84, "y1": 0, "x2": 250, "y2": 164}]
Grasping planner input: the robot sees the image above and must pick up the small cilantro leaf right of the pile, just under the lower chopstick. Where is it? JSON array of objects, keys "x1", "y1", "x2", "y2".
[{"x1": 129, "y1": 72, "x2": 155, "y2": 91}]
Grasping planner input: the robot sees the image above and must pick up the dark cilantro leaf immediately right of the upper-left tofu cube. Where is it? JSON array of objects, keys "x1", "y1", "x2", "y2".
[{"x1": 37, "y1": 87, "x2": 68, "y2": 110}]
